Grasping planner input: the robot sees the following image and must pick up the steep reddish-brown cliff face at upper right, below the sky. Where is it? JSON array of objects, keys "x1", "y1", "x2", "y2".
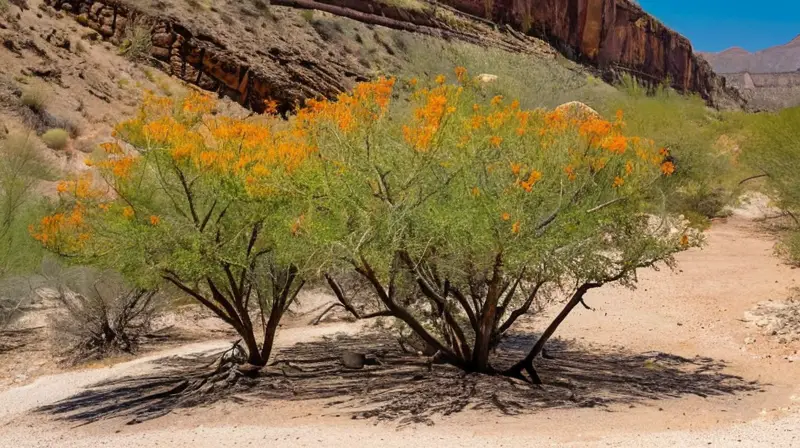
[{"x1": 443, "y1": 0, "x2": 740, "y2": 107}]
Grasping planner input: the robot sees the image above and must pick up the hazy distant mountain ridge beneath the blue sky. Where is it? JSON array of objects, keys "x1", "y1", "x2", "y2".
[{"x1": 700, "y1": 34, "x2": 800, "y2": 74}]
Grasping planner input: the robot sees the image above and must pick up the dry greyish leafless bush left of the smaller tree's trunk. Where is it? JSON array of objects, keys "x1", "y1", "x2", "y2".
[{"x1": 46, "y1": 264, "x2": 158, "y2": 362}]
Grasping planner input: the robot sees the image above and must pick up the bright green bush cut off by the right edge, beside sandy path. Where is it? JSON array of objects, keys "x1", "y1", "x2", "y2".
[{"x1": 742, "y1": 107, "x2": 800, "y2": 263}]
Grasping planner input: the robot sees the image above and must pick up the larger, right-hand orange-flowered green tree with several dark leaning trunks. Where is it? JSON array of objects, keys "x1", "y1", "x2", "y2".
[{"x1": 292, "y1": 68, "x2": 698, "y2": 382}]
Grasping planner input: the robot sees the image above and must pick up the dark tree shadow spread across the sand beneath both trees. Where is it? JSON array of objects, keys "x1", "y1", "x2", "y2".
[{"x1": 39, "y1": 334, "x2": 761, "y2": 424}]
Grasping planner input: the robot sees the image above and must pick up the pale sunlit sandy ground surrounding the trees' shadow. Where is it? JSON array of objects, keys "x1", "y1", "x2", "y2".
[{"x1": 0, "y1": 213, "x2": 800, "y2": 447}]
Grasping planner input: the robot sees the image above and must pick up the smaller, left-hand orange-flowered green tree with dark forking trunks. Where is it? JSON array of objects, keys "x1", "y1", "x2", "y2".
[{"x1": 31, "y1": 93, "x2": 314, "y2": 367}]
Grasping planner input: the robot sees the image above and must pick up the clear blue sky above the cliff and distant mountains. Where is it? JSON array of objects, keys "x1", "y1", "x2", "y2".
[{"x1": 639, "y1": 0, "x2": 800, "y2": 52}]
